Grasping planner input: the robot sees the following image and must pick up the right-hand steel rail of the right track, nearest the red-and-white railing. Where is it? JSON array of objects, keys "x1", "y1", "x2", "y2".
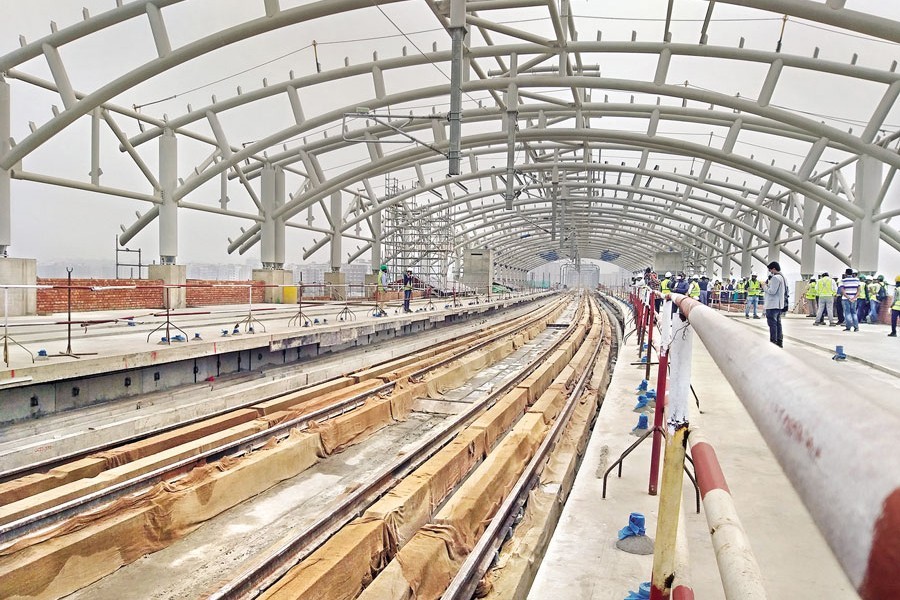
[{"x1": 441, "y1": 300, "x2": 611, "y2": 600}]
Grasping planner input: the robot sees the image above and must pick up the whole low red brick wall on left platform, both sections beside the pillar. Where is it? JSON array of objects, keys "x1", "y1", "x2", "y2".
[{"x1": 37, "y1": 277, "x2": 264, "y2": 315}]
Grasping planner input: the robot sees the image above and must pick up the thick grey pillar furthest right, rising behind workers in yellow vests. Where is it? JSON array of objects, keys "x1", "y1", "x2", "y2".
[{"x1": 850, "y1": 156, "x2": 883, "y2": 275}]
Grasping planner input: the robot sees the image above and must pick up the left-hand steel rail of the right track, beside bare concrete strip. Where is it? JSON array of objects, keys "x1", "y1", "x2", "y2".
[{"x1": 208, "y1": 296, "x2": 578, "y2": 600}]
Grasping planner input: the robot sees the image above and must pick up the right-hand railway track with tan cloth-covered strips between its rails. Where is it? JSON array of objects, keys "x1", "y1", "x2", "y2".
[{"x1": 209, "y1": 296, "x2": 611, "y2": 599}]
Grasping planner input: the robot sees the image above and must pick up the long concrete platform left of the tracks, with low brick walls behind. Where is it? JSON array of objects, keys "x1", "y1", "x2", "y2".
[{"x1": 0, "y1": 295, "x2": 545, "y2": 422}]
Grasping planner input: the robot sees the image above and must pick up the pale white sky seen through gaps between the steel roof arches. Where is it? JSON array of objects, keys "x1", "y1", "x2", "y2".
[{"x1": 0, "y1": 0, "x2": 900, "y2": 278}]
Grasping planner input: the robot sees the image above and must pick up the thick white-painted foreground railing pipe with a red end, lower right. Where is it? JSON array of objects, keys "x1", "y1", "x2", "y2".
[{"x1": 672, "y1": 294, "x2": 900, "y2": 600}]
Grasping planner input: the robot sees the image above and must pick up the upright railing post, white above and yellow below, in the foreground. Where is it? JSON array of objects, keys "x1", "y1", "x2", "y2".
[{"x1": 650, "y1": 302, "x2": 692, "y2": 600}]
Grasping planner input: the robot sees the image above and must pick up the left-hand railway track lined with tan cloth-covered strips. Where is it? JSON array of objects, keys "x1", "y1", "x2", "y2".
[{"x1": 0, "y1": 292, "x2": 576, "y2": 597}]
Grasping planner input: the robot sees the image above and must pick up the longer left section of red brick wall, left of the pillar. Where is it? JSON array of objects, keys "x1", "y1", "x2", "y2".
[{"x1": 37, "y1": 277, "x2": 163, "y2": 315}]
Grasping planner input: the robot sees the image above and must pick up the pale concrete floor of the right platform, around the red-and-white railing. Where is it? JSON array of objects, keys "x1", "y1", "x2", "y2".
[{"x1": 529, "y1": 304, "x2": 900, "y2": 600}]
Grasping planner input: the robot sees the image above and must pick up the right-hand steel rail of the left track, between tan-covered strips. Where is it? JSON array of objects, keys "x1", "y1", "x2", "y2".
[{"x1": 0, "y1": 301, "x2": 562, "y2": 543}]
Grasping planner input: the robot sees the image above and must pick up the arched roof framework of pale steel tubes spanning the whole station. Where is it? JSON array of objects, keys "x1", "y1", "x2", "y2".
[{"x1": 0, "y1": 0, "x2": 900, "y2": 275}]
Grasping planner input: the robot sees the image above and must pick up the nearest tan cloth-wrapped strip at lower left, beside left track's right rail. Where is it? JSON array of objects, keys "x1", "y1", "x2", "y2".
[{"x1": 0, "y1": 432, "x2": 322, "y2": 600}]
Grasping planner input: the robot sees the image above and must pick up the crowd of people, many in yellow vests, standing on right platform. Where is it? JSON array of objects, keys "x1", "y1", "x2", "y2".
[{"x1": 635, "y1": 261, "x2": 900, "y2": 346}]
